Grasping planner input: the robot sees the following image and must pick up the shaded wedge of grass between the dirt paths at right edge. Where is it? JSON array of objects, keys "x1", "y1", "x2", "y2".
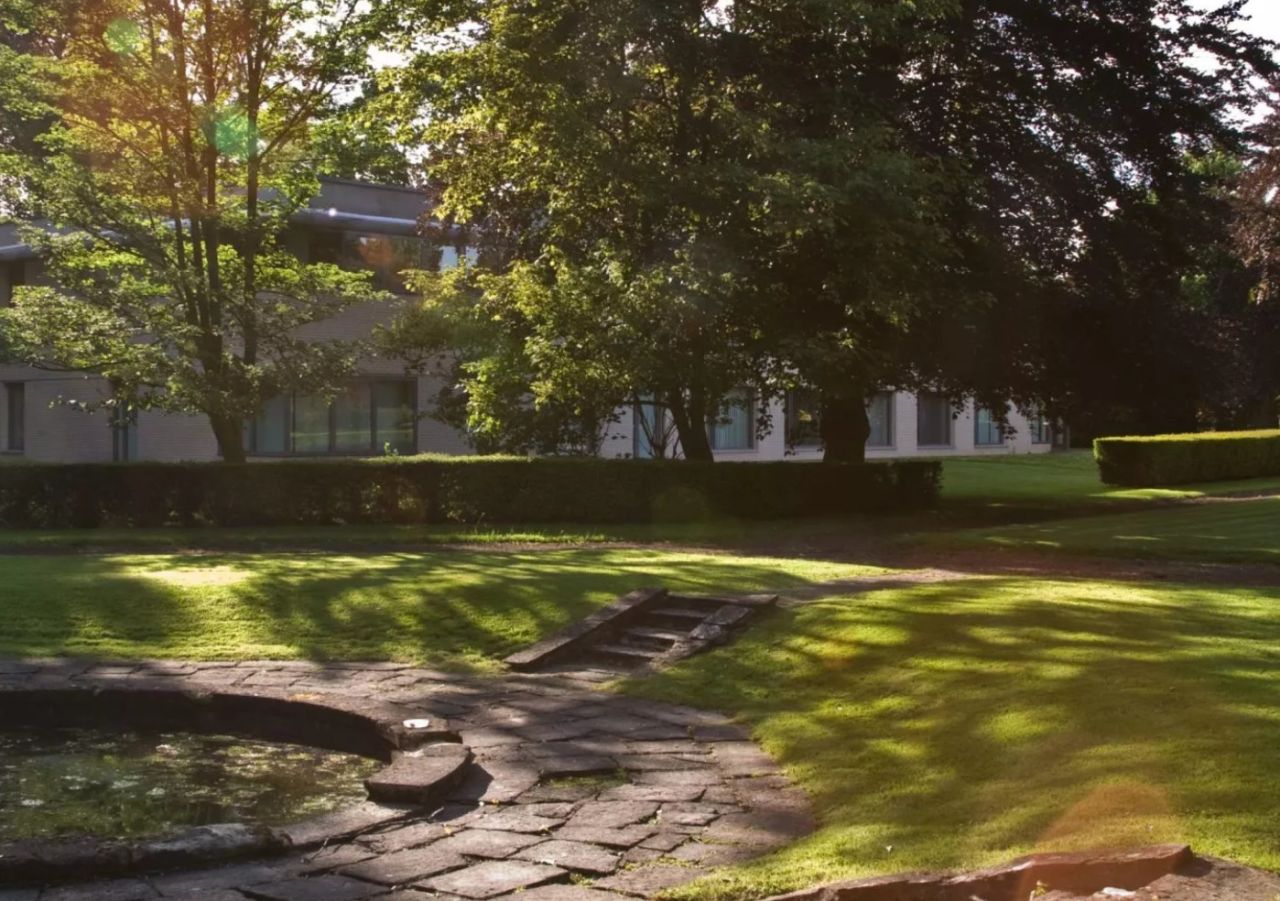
[{"x1": 936, "y1": 497, "x2": 1280, "y2": 563}]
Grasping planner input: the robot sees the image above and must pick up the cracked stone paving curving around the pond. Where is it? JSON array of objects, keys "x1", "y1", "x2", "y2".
[{"x1": 0, "y1": 660, "x2": 812, "y2": 901}]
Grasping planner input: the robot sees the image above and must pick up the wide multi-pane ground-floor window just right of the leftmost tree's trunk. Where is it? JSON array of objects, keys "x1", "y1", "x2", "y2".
[{"x1": 248, "y1": 379, "x2": 417, "y2": 456}]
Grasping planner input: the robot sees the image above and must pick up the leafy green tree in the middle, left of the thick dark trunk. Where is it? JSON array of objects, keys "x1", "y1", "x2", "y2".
[{"x1": 384, "y1": 0, "x2": 957, "y2": 459}]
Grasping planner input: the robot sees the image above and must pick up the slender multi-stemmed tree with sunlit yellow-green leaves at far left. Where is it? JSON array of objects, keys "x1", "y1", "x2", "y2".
[{"x1": 0, "y1": 0, "x2": 378, "y2": 462}]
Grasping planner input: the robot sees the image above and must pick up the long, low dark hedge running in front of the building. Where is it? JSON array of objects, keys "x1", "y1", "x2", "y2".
[{"x1": 0, "y1": 457, "x2": 941, "y2": 529}]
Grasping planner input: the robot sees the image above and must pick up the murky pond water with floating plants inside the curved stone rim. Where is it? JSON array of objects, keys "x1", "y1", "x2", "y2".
[{"x1": 0, "y1": 728, "x2": 384, "y2": 841}]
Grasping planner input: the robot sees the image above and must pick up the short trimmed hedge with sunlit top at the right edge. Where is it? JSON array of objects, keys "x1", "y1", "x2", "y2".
[{"x1": 1093, "y1": 430, "x2": 1280, "y2": 488}]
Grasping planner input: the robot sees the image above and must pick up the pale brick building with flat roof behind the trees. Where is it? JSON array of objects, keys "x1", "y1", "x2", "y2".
[{"x1": 0, "y1": 179, "x2": 1052, "y2": 462}]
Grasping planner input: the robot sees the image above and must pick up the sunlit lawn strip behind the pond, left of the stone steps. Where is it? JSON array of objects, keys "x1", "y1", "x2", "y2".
[{"x1": 0, "y1": 549, "x2": 874, "y2": 668}]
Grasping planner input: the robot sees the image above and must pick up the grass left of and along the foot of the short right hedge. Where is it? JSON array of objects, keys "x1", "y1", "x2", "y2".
[{"x1": 942, "y1": 451, "x2": 1280, "y2": 507}]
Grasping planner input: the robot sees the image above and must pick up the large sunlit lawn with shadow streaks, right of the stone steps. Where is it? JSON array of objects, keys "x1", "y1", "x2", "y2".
[{"x1": 623, "y1": 580, "x2": 1280, "y2": 900}]
